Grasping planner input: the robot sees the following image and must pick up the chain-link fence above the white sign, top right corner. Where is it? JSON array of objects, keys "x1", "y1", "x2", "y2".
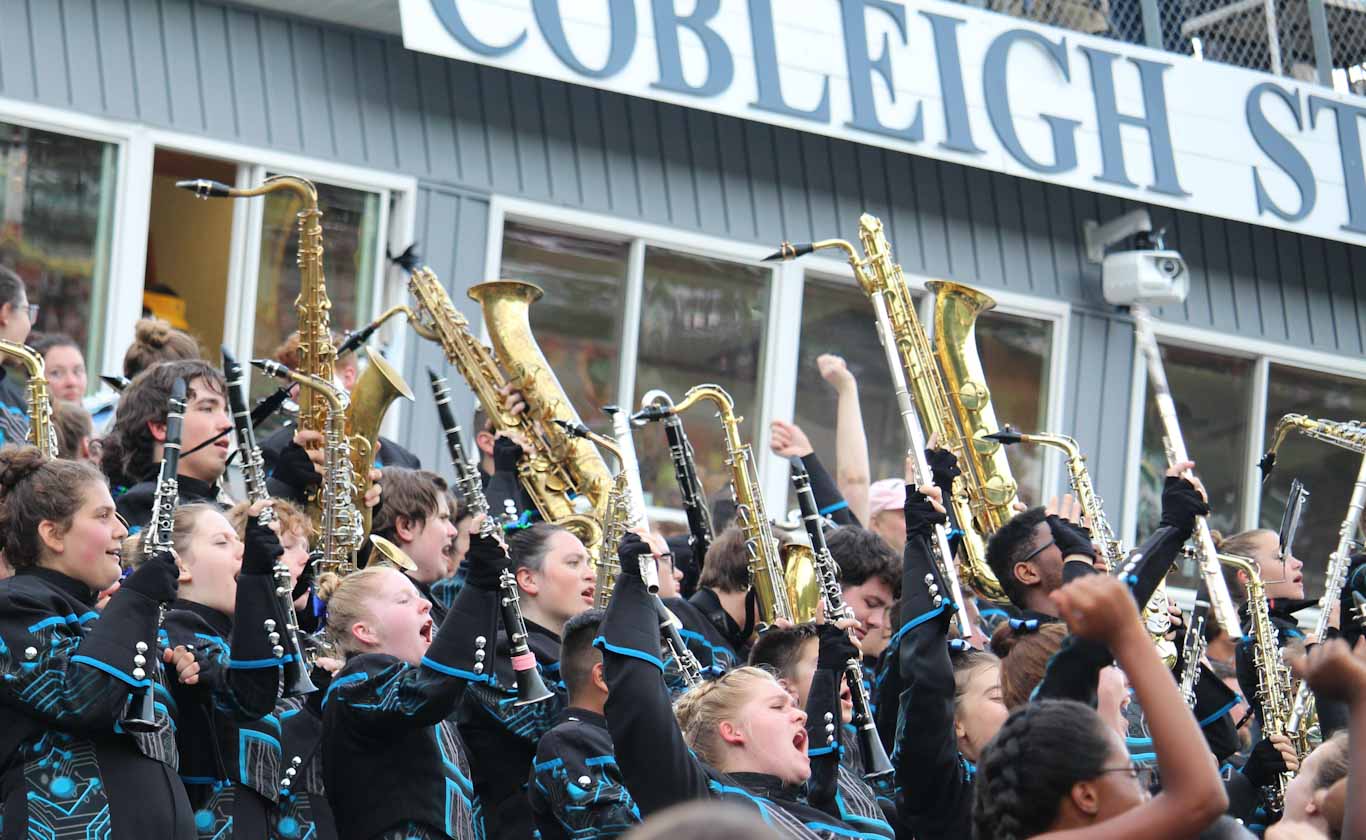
[{"x1": 966, "y1": 0, "x2": 1366, "y2": 94}]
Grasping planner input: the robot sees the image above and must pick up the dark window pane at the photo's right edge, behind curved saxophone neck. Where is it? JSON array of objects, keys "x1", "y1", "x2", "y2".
[{"x1": 1259, "y1": 365, "x2": 1366, "y2": 598}]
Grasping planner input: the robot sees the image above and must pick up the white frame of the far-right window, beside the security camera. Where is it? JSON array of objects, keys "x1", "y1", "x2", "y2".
[{"x1": 1120, "y1": 318, "x2": 1366, "y2": 606}]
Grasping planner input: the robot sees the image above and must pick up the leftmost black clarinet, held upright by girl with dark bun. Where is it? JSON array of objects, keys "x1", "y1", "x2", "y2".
[{"x1": 119, "y1": 378, "x2": 184, "y2": 732}]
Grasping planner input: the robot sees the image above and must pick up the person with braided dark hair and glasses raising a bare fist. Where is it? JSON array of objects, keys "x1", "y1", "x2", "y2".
[{"x1": 973, "y1": 575, "x2": 1228, "y2": 840}]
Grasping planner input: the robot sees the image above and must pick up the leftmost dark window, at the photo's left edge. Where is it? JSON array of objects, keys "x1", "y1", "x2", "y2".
[{"x1": 0, "y1": 123, "x2": 117, "y2": 384}]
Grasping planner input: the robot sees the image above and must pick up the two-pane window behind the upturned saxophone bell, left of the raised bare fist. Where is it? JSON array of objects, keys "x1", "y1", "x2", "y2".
[{"x1": 499, "y1": 219, "x2": 773, "y2": 508}]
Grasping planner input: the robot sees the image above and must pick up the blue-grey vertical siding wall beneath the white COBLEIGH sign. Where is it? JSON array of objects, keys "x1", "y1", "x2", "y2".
[{"x1": 0, "y1": 0, "x2": 1366, "y2": 513}]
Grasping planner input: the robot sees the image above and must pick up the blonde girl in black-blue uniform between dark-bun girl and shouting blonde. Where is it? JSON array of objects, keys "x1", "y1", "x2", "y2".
[{"x1": 165, "y1": 503, "x2": 285, "y2": 839}]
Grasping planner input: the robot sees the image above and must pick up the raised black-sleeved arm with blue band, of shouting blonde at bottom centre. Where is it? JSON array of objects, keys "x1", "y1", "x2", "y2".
[{"x1": 594, "y1": 534, "x2": 710, "y2": 818}]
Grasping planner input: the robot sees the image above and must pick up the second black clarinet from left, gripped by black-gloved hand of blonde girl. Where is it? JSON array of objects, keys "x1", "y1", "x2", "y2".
[{"x1": 223, "y1": 347, "x2": 318, "y2": 697}]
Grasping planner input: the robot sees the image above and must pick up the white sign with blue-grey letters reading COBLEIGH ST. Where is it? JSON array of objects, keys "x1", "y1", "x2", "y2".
[{"x1": 400, "y1": 0, "x2": 1366, "y2": 244}]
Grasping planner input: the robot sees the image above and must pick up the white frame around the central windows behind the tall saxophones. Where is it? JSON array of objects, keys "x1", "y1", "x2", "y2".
[{"x1": 479, "y1": 194, "x2": 1072, "y2": 523}]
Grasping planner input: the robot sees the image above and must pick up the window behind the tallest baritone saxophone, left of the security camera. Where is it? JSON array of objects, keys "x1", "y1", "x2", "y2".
[{"x1": 790, "y1": 282, "x2": 1052, "y2": 516}]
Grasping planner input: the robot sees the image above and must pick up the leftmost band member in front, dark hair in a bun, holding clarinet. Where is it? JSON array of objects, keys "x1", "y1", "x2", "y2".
[{"x1": 0, "y1": 447, "x2": 195, "y2": 840}]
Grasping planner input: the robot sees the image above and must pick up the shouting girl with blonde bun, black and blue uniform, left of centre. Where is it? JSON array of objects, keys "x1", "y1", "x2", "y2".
[{"x1": 319, "y1": 565, "x2": 486, "y2": 840}]
